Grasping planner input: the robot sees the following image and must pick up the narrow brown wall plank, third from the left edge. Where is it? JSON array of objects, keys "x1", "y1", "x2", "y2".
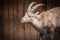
[{"x1": 8, "y1": 0, "x2": 13, "y2": 40}]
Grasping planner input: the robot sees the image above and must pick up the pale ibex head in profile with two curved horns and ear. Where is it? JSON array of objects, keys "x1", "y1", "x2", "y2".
[{"x1": 21, "y1": 2, "x2": 44, "y2": 23}]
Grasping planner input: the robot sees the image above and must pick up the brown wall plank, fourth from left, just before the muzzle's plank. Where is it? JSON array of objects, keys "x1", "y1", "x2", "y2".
[{"x1": 13, "y1": 0, "x2": 18, "y2": 40}]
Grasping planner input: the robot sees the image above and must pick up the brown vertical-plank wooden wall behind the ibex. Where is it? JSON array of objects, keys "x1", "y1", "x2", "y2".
[{"x1": 0, "y1": 0, "x2": 60, "y2": 40}]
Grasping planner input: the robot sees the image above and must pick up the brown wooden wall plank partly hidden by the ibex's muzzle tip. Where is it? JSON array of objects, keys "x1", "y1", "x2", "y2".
[{"x1": 17, "y1": 0, "x2": 25, "y2": 40}]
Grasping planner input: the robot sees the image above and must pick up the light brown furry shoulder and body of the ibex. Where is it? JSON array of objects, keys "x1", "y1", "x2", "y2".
[{"x1": 35, "y1": 7, "x2": 60, "y2": 27}]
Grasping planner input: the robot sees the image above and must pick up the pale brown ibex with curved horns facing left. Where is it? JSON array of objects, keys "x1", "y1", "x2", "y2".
[{"x1": 21, "y1": 2, "x2": 60, "y2": 40}]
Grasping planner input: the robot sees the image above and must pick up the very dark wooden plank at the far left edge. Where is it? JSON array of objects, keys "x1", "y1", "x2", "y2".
[{"x1": 0, "y1": 0, "x2": 3, "y2": 40}]
